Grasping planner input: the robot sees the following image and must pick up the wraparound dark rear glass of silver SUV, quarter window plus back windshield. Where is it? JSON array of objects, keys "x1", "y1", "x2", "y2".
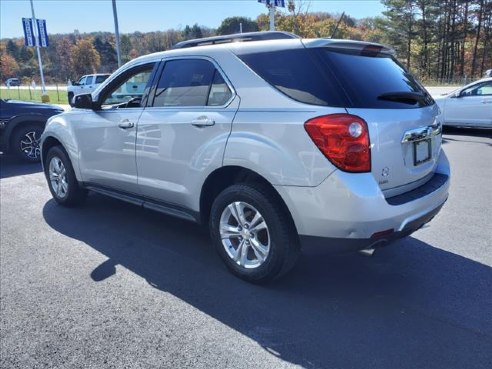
[{"x1": 239, "y1": 48, "x2": 434, "y2": 109}]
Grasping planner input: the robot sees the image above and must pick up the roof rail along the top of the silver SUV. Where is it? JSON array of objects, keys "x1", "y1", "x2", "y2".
[{"x1": 172, "y1": 31, "x2": 300, "y2": 49}]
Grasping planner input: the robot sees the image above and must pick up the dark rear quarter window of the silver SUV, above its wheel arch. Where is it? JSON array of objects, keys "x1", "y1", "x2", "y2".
[{"x1": 239, "y1": 49, "x2": 347, "y2": 106}]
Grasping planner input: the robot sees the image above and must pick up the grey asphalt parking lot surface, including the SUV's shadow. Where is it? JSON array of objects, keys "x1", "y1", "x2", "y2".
[{"x1": 0, "y1": 129, "x2": 492, "y2": 369}]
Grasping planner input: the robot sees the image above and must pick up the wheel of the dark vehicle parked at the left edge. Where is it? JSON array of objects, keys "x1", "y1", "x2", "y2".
[{"x1": 10, "y1": 123, "x2": 44, "y2": 163}]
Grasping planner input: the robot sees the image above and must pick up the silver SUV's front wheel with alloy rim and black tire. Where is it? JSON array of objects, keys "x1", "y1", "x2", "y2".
[{"x1": 44, "y1": 146, "x2": 87, "y2": 207}]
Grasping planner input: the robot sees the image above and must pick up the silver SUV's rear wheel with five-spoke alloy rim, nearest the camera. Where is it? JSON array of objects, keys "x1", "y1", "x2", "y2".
[{"x1": 210, "y1": 184, "x2": 300, "y2": 284}]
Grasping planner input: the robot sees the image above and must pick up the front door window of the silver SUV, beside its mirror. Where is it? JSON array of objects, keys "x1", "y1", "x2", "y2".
[{"x1": 102, "y1": 63, "x2": 155, "y2": 108}]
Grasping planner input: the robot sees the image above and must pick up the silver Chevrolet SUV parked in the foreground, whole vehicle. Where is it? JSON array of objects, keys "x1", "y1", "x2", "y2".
[{"x1": 42, "y1": 33, "x2": 450, "y2": 283}]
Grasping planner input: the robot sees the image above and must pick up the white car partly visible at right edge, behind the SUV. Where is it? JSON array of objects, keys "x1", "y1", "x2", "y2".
[{"x1": 435, "y1": 78, "x2": 492, "y2": 128}]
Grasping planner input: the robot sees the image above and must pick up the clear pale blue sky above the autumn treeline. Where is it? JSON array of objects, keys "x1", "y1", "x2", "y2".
[{"x1": 0, "y1": 0, "x2": 384, "y2": 38}]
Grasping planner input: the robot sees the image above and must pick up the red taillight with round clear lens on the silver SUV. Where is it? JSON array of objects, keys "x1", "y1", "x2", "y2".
[{"x1": 304, "y1": 114, "x2": 371, "y2": 173}]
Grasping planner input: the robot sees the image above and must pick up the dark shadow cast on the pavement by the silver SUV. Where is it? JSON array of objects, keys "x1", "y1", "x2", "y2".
[{"x1": 43, "y1": 194, "x2": 492, "y2": 369}]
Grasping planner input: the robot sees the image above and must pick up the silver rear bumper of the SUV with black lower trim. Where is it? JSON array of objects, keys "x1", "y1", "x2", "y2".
[{"x1": 276, "y1": 152, "x2": 450, "y2": 249}]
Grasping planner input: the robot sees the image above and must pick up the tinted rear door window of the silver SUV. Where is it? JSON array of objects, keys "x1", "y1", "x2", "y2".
[{"x1": 153, "y1": 59, "x2": 231, "y2": 106}]
